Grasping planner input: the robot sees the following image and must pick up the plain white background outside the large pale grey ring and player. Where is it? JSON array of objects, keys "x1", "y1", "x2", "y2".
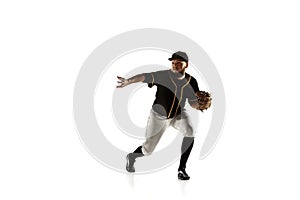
[{"x1": 0, "y1": 0, "x2": 300, "y2": 199}]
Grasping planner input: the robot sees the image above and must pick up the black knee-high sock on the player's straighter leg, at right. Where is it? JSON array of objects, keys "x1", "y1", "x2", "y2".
[{"x1": 178, "y1": 137, "x2": 194, "y2": 170}]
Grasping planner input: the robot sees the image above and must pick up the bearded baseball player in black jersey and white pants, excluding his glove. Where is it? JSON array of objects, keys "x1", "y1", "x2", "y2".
[{"x1": 117, "y1": 51, "x2": 199, "y2": 180}]
